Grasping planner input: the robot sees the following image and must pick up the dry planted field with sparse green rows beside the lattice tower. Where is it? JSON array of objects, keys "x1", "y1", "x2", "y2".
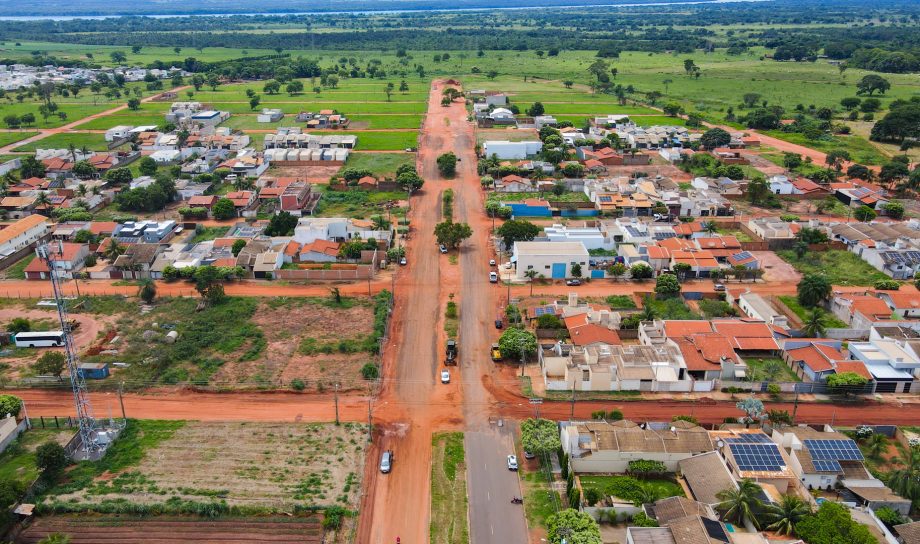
[{"x1": 41, "y1": 420, "x2": 367, "y2": 513}]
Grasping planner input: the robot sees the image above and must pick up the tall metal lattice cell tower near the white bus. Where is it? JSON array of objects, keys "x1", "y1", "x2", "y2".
[{"x1": 38, "y1": 242, "x2": 105, "y2": 458}]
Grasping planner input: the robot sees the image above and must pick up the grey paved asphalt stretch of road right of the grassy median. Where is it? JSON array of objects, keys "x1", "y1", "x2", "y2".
[{"x1": 465, "y1": 427, "x2": 527, "y2": 544}]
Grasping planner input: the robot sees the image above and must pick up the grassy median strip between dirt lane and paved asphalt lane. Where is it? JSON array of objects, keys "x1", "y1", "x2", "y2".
[{"x1": 429, "y1": 433, "x2": 470, "y2": 544}]
